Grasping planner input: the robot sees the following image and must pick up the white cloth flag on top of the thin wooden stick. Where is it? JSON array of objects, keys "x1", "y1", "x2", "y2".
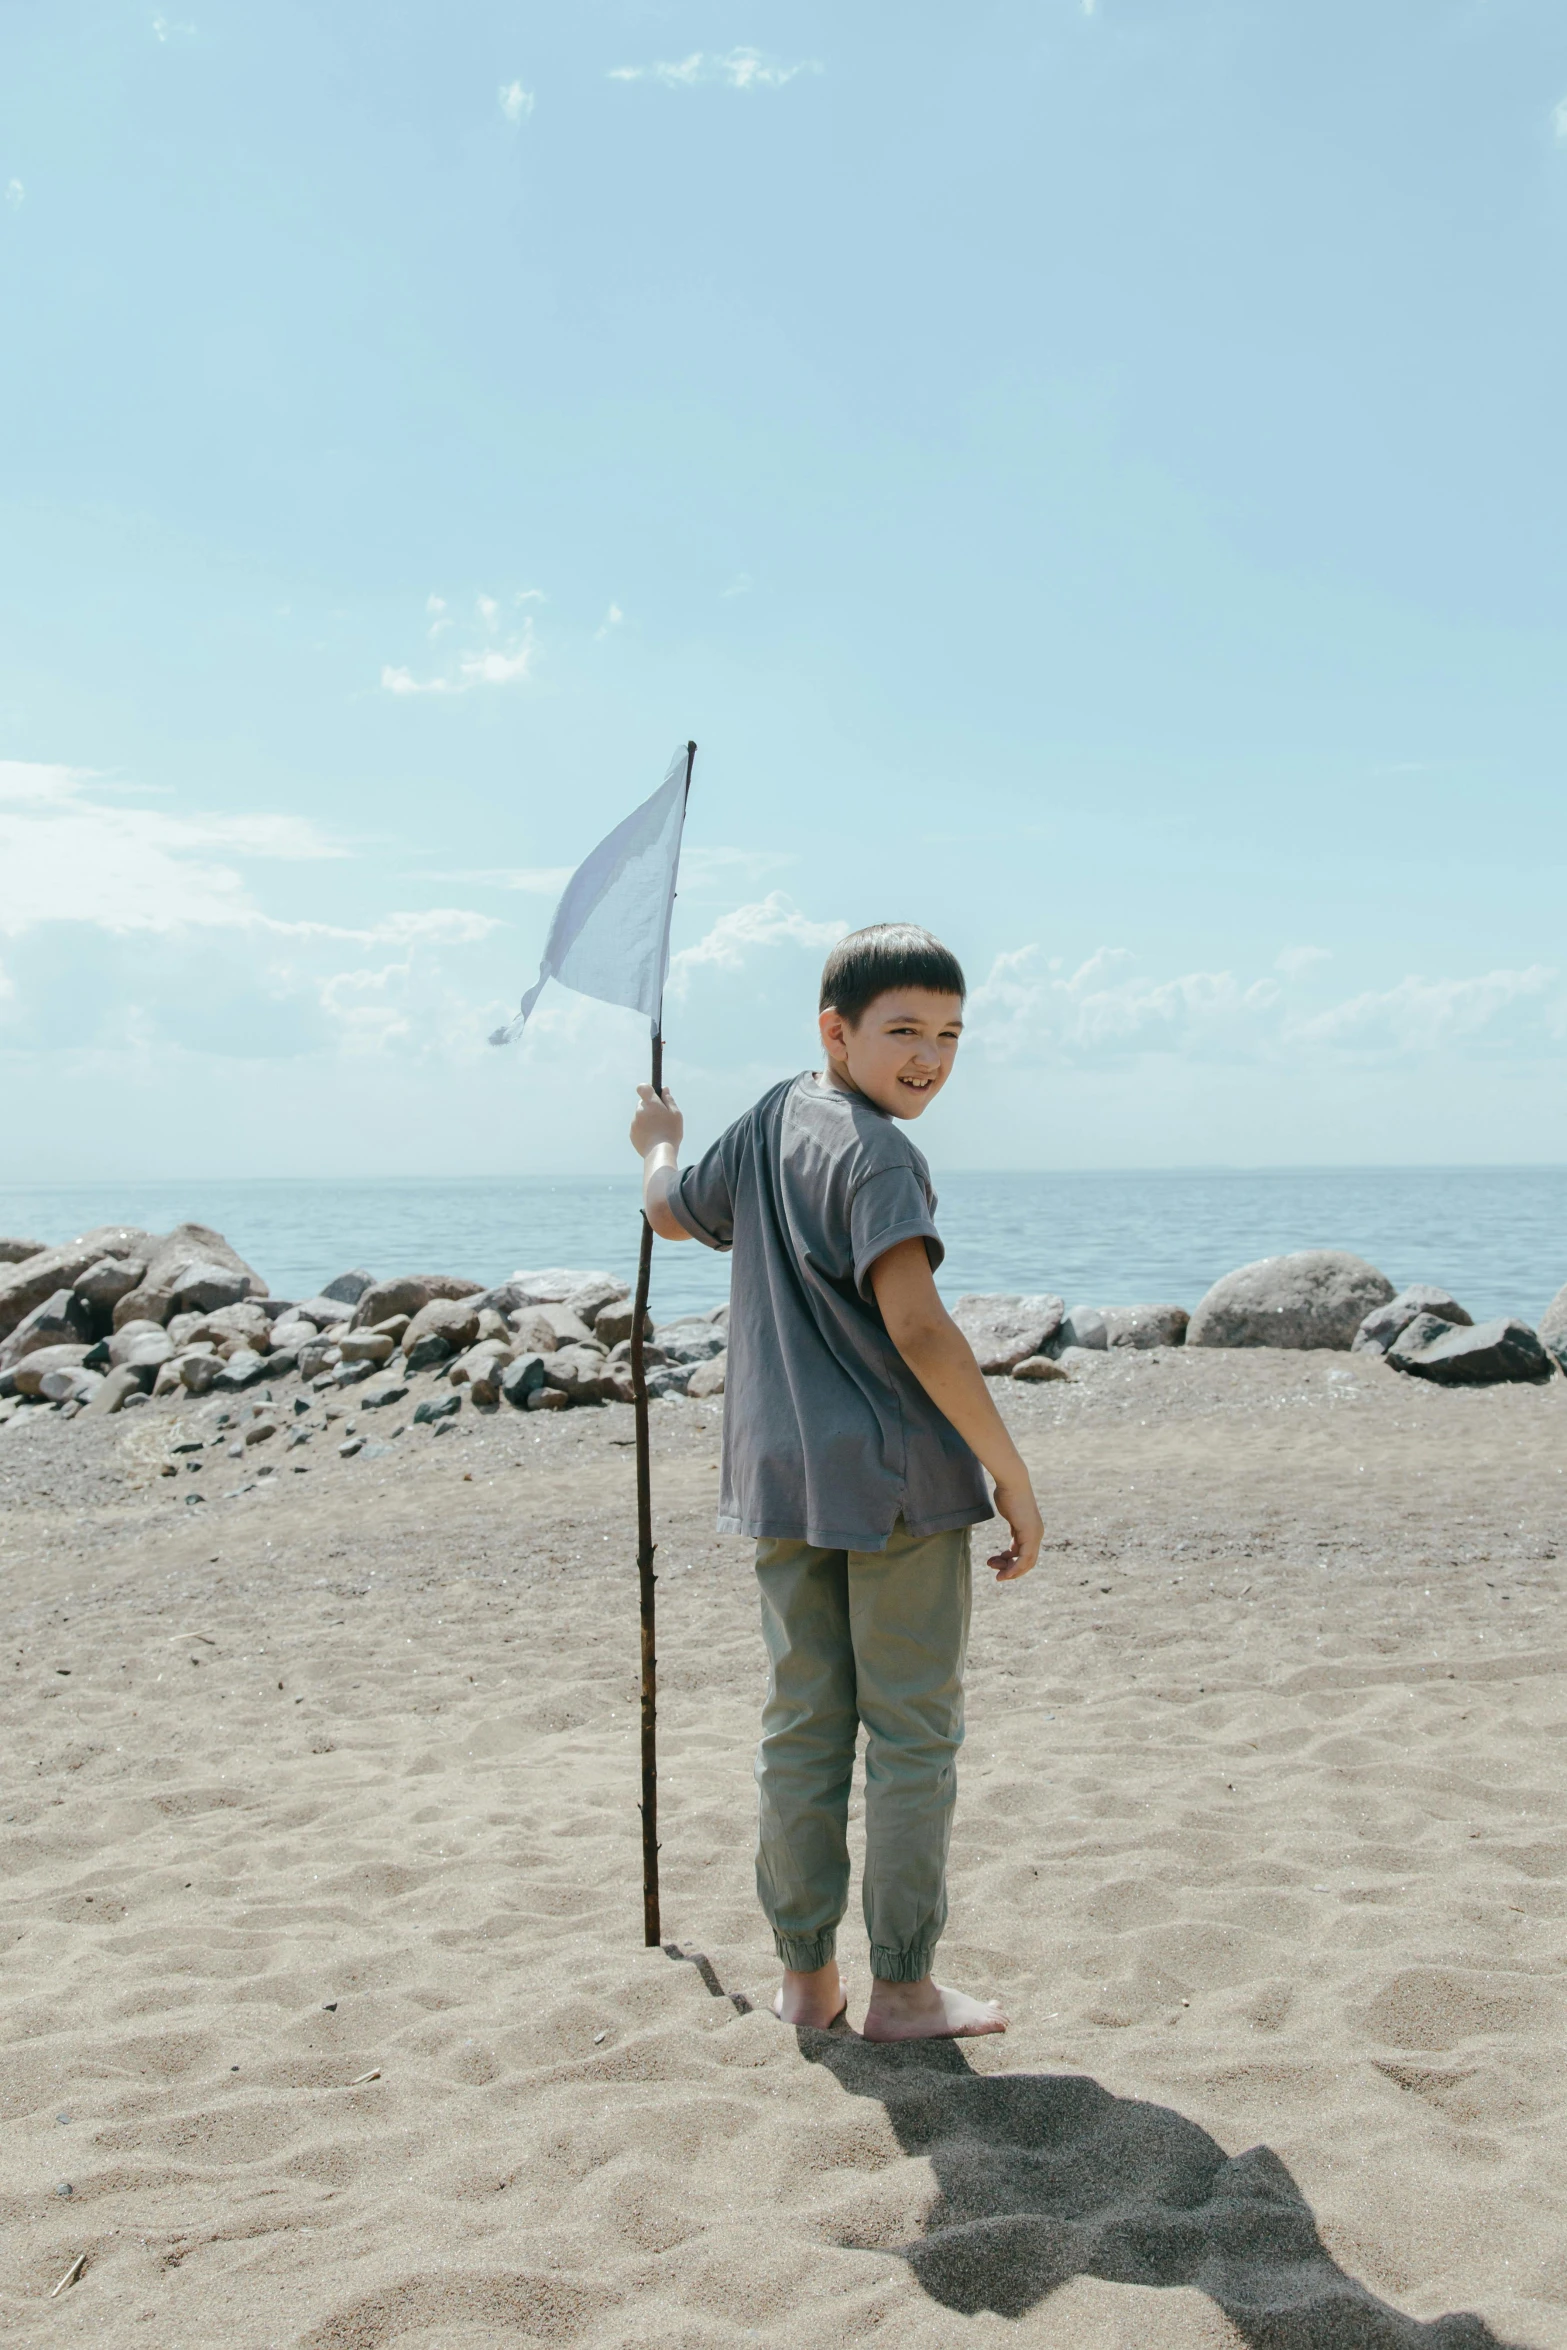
[{"x1": 489, "y1": 743, "x2": 691, "y2": 1043}]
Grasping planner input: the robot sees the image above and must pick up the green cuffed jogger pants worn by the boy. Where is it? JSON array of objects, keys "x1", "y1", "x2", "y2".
[{"x1": 756, "y1": 1518, "x2": 970, "y2": 1983}]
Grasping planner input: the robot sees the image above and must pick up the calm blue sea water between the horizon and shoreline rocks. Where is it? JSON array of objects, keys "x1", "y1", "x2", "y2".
[{"x1": 0, "y1": 1168, "x2": 1567, "y2": 1321}]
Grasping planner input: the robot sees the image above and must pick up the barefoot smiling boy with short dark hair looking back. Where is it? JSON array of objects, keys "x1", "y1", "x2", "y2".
[{"x1": 632, "y1": 921, "x2": 1043, "y2": 2040}]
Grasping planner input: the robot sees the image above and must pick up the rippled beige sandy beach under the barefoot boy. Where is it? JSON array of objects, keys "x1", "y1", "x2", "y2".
[{"x1": 0, "y1": 1349, "x2": 1567, "y2": 2350}]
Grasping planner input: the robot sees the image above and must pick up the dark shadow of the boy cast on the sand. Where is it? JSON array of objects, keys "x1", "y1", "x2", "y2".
[{"x1": 796, "y1": 2030, "x2": 1508, "y2": 2350}]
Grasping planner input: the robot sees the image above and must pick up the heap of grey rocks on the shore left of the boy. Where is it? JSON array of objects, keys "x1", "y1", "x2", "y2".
[{"x1": 0, "y1": 1224, "x2": 728, "y2": 1424}]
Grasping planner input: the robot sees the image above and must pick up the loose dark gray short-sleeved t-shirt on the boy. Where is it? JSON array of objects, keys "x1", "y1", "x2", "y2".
[{"x1": 670, "y1": 1074, "x2": 991, "y2": 1551}]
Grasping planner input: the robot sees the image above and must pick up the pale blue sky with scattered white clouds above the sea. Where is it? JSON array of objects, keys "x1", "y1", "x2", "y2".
[{"x1": 0, "y1": 0, "x2": 1567, "y2": 1180}]
